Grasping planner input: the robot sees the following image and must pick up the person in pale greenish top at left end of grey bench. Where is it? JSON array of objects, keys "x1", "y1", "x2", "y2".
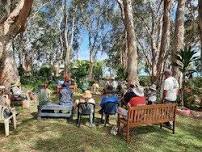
[{"x1": 38, "y1": 83, "x2": 50, "y2": 106}]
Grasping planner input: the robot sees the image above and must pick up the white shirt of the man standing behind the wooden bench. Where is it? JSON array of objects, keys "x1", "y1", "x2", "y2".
[{"x1": 163, "y1": 77, "x2": 179, "y2": 101}]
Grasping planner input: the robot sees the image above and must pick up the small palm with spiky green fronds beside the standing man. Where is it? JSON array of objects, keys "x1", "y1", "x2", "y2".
[{"x1": 174, "y1": 47, "x2": 199, "y2": 107}]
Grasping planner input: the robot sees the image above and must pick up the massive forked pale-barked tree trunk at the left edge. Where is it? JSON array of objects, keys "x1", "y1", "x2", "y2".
[{"x1": 0, "y1": 0, "x2": 33, "y2": 86}]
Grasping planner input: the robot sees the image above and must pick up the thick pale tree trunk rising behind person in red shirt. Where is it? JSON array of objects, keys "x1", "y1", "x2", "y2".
[{"x1": 123, "y1": 0, "x2": 138, "y2": 82}]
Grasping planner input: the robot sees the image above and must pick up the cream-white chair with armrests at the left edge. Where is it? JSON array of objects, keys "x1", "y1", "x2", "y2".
[{"x1": 0, "y1": 105, "x2": 16, "y2": 136}]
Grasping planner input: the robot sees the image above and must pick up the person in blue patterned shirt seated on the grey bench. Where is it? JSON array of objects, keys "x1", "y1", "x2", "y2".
[{"x1": 59, "y1": 83, "x2": 72, "y2": 105}]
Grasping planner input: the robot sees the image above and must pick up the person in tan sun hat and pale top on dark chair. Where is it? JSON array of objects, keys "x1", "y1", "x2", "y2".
[{"x1": 75, "y1": 90, "x2": 95, "y2": 126}]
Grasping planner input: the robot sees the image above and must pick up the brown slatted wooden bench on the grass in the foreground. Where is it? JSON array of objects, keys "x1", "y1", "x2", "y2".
[{"x1": 117, "y1": 104, "x2": 176, "y2": 142}]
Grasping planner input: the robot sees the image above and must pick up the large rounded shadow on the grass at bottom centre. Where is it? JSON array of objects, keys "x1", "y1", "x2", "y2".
[{"x1": 34, "y1": 122, "x2": 129, "y2": 152}]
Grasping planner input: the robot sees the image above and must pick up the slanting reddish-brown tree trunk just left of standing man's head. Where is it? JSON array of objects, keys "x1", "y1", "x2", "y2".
[{"x1": 156, "y1": 0, "x2": 171, "y2": 86}]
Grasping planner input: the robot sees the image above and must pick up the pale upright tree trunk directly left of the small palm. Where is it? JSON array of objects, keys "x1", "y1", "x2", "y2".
[{"x1": 172, "y1": 0, "x2": 185, "y2": 80}]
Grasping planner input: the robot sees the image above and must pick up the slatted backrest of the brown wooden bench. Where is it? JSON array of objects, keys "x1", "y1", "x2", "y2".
[{"x1": 128, "y1": 104, "x2": 176, "y2": 124}]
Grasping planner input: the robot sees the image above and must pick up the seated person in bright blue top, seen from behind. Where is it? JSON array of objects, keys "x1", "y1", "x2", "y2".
[{"x1": 99, "y1": 85, "x2": 119, "y2": 114}]
